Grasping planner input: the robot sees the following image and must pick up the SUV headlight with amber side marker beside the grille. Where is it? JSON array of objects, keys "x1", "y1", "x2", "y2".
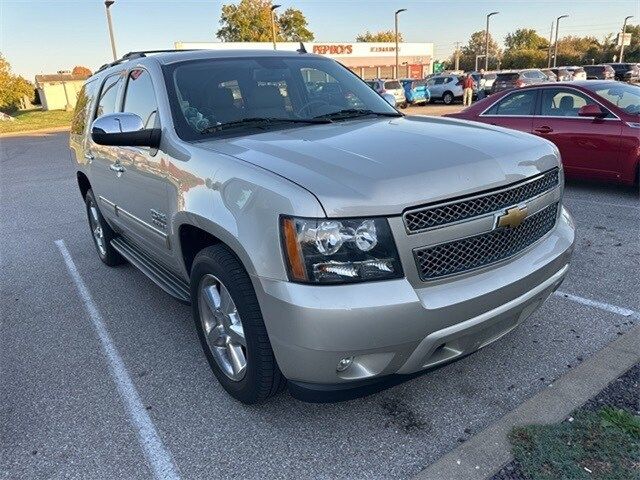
[{"x1": 280, "y1": 217, "x2": 402, "y2": 283}]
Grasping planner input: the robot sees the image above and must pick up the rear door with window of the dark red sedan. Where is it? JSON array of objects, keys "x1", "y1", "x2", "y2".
[{"x1": 480, "y1": 88, "x2": 538, "y2": 133}]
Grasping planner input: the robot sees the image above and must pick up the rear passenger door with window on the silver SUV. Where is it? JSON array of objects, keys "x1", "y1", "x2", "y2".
[{"x1": 86, "y1": 72, "x2": 124, "y2": 225}]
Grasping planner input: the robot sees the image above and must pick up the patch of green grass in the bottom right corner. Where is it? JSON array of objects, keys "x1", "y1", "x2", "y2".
[{"x1": 509, "y1": 407, "x2": 640, "y2": 480}]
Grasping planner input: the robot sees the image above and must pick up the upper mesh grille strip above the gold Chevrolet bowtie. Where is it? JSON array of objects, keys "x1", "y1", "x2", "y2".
[{"x1": 404, "y1": 168, "x2": 559, "y2": 234}]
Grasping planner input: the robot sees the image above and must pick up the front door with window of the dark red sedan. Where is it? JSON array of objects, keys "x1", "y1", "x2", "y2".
[{"x1": 533, "y1": 87, "x2": 622, "y2": 178}]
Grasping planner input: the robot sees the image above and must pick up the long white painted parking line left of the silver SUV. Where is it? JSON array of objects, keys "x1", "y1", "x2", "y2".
[{"x1": 55, "y1": 240, "x2": 180, "y2": 480}]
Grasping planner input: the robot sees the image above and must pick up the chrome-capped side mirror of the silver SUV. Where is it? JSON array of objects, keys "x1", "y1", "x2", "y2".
[{"x1": 91, "y1": 113, "x2": 160, "y2": 148}]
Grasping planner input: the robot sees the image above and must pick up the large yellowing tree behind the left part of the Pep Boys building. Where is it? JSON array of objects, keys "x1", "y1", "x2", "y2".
[{"x1": 216, "y1": 0, "x2": 314, "y2": 42}]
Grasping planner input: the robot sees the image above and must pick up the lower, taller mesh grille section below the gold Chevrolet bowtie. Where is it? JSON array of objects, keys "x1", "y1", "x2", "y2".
[{"x1": 414, "y1": 203, "x2": 558, "y2": 280}]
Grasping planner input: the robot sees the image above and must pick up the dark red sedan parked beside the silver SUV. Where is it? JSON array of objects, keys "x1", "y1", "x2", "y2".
[{"x1": 446, "y1": 80, "x2": 640, "y2": 184}]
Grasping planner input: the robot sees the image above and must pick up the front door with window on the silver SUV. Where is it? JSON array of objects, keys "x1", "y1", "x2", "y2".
[{"x1": 117, "y1": 68, "x2": 170, "y2": 263}]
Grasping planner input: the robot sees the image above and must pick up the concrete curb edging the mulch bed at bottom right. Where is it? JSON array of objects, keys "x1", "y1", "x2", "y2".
[{"x1": 413, "y1": 326, "x2": 640, "y2": 480}]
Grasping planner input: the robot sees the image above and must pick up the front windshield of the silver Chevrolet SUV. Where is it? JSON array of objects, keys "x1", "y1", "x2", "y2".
[{"x1": 163, "y1": 55, "x2": 400, "y2": 140}]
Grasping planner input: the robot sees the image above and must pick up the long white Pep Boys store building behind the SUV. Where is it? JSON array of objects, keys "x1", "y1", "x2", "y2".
[{"x1": 175, "y1": 42, "x2": 433, "y2": 79}]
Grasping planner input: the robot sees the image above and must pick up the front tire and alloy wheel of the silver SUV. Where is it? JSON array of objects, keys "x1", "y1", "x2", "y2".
[{"x1": 191, "y1": 245, "x2": 286, "y2": 404}]
